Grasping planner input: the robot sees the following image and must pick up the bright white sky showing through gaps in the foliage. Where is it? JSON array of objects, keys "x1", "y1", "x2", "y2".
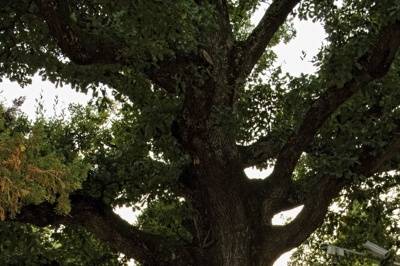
[{"x1": 0, "y1": 5, "x2": 325, "y2": 266}]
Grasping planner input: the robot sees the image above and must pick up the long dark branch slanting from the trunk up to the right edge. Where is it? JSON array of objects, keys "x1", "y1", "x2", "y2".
[{"x1": 269, "y1": 21, "x2": 400, "y2": 186}]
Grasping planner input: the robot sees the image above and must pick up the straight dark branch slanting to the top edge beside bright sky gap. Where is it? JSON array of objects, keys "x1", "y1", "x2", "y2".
[{"x1": 235, "y1": 0, "x2": 300, "y2": 79}]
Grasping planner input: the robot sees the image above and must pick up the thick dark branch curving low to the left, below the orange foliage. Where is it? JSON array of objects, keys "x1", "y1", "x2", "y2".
[{"x1": 16, "y1": 195, "x2": 192, "y2": 265}]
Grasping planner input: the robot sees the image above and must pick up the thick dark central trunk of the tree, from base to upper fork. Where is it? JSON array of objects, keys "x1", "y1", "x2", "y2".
[{"x1": 172, "y1": 47, "x2": 290, "y2": 266}]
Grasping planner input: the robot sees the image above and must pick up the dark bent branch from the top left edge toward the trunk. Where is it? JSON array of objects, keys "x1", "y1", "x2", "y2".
[{"x1": 36, "y1": 0, "x2": 195, "y2": 92}]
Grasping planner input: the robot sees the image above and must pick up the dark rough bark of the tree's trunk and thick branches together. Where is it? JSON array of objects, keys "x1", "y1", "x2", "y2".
[{"x1": 7, "y1": 0, "x2": 400, "y2": 266}]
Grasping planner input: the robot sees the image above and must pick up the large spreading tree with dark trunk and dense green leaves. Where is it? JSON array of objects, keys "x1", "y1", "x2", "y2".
[{"x1": 0, "y1": 0, "x2": 400, "y2": 266}]
